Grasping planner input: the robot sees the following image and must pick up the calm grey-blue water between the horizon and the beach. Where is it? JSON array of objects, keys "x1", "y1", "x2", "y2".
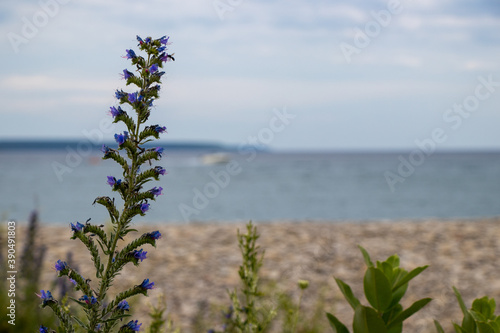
[{"x1": 0, "y1": 151, "x2": 500, "y2": 224}]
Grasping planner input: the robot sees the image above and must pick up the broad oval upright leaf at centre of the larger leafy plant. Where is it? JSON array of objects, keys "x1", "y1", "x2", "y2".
[{"x1": 363, "y1": 267, "x2": 392, "y2": 312}]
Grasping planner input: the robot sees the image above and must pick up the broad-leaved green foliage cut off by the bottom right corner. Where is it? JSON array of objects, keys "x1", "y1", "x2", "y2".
[{"x1": 434, "y1": 287, "x2": 500, "y2": 333}]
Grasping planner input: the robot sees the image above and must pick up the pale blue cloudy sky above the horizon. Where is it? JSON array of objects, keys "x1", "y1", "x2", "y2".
[{"x1": 0, "y1": 0, "x2": 500, "y2": 151}]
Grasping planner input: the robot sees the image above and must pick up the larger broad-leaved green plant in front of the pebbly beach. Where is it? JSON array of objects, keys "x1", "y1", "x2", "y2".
[{"x1": 326, "y1": 246, "x2": 431, "y2": 333}]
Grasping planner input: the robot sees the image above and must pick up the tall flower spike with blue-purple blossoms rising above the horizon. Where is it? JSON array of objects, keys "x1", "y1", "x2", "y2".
[{"x1": 38, "y1": 36, "x2": 173, "y2": 333}]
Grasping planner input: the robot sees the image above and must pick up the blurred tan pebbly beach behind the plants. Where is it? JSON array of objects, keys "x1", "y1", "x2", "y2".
[{"x1": 19, "y1": 218, "x2": 500, "y2": 332}]
